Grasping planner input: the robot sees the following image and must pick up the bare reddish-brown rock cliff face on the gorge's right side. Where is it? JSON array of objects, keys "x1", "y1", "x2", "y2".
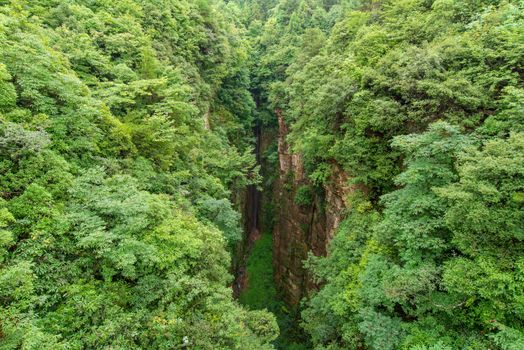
[{"x1": 273, "y1": 111, "x2": 351, "y2": 305}]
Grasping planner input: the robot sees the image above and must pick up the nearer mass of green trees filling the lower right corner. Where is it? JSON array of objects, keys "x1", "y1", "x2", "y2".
[{"x1": 303, "y1": 122, "x2": 524, "y2": 349}]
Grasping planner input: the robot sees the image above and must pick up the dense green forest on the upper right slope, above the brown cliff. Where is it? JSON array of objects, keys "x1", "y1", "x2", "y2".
[{"x1": 255, "y1": 1, "x2": 522, "y2": 199}]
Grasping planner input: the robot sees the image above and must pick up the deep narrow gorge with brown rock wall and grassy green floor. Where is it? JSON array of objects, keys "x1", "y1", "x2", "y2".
[{"x1": 233, "y1": 114, "x2": 353, "y2": 349}]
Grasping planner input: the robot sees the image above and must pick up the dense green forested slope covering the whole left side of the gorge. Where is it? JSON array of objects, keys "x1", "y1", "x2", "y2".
[{"x1": 0, "y1": 0, "x2": 278, "y2": 350}]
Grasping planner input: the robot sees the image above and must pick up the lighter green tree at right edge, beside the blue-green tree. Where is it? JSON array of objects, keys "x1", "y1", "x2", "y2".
[{"x1": 437, "y1": 133, "x2": 524, "y2": 348}]
